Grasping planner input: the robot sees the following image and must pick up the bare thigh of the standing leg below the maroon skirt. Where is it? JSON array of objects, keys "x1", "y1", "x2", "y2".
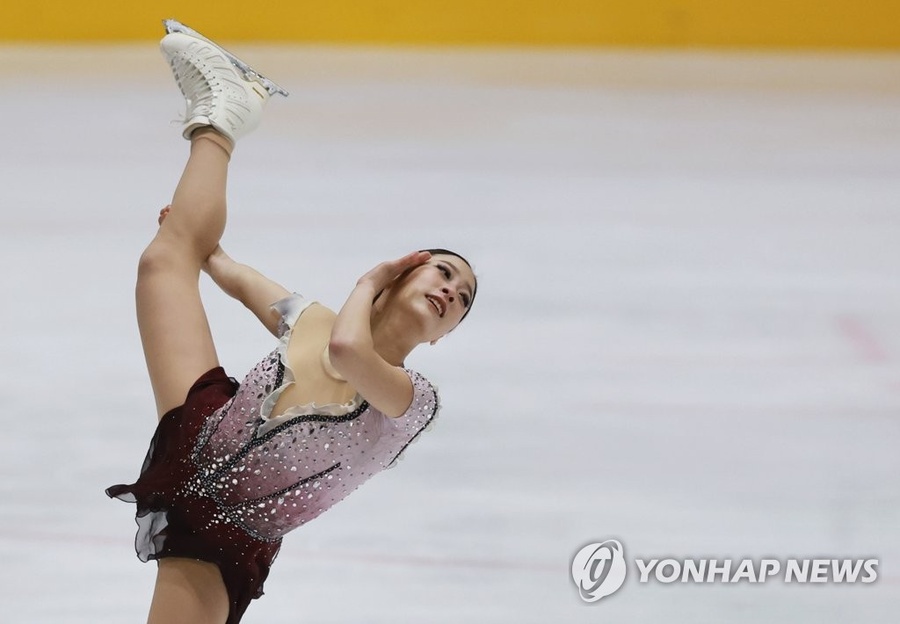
[{"x1": 147, "y1": 557, "x2": 228, "y2": 624}]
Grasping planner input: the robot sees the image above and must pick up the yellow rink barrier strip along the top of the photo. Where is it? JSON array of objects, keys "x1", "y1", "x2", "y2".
[{"x1": 0, "y1": 0, "x2": 900, "y2": 49}]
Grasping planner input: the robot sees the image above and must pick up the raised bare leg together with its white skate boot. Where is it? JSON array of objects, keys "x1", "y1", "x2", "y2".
[{"x1": 136, "y1": 25, "x2": 284, "y2": 416}]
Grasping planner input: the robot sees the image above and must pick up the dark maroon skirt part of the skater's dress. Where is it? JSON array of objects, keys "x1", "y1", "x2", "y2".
[{"x1": 106, "y1": 367, "x2": 281, "y2": 624}]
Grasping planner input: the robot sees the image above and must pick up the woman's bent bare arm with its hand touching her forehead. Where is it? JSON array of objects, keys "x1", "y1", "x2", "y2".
[{"x1": 328, "y1": 252, "x2": 431, "y2": 417}]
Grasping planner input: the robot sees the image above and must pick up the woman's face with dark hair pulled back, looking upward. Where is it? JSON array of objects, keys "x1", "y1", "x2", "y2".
[{"x1": 401, "y1": 254, "x2": 475, "y2": 341}]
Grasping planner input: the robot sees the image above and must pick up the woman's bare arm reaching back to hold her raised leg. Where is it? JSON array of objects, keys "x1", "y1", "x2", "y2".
[{"x1": 203, "y1": 247, "x2": 291, "y2": 336}]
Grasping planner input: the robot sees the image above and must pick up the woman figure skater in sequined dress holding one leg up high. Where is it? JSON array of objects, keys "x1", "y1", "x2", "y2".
[{"x1": 107, "y1": 21, "x2": 477, "y2": 624}]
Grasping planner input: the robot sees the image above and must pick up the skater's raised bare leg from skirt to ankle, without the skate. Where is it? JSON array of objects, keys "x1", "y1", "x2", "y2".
[{"x1": 136, "y1": 128, "x2": 230, "y2": 417}]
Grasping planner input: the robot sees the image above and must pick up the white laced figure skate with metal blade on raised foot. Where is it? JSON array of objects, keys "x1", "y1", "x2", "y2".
[{"x1": 160, "y1": 20, "x2": 287, "y2": 143}]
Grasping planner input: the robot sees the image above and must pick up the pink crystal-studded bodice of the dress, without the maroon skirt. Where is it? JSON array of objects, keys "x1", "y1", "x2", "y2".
[{"x1": 180, "y1": 295, "x2": 439, "y2": 540}]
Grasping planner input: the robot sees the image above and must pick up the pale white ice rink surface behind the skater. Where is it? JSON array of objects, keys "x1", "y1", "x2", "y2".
[{"x1": 0, "y1": 43, "x2": 900, "y2": 624}]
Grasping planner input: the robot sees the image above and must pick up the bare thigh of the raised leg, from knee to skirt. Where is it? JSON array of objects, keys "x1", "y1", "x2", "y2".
[{"x1": 135, "y1": 236, "x2": 219, "y2": 417}]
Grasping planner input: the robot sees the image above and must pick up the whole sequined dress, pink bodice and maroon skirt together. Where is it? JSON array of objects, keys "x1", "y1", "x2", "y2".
[{"x1": 107, "y1": 295, "x2": 439, "y2": 624}]
